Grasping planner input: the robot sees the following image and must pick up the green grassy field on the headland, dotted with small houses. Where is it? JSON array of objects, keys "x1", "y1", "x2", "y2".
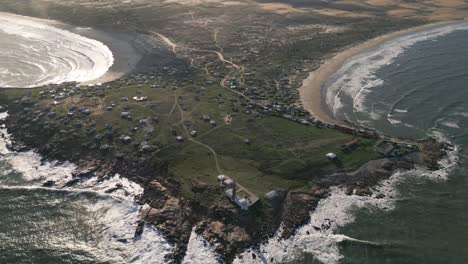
[{"x1": 0, "y1": 69, "x2": 378, "y2": 197}]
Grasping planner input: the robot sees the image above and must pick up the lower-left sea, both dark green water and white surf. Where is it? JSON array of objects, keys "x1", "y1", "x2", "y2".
[{"x1": 0, "y1": 113, "x2": 176, "y2": 264}]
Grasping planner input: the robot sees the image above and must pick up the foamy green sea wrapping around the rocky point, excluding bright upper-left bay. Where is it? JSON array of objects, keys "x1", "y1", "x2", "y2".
[{"x1": 0, "y1": 20, "x2": 468, "y2": 264}]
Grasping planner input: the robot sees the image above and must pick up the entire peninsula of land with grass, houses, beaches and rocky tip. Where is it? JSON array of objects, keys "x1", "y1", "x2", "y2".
[{"x1": 0, "y1": 0, "x2": 462, "y2": 263}]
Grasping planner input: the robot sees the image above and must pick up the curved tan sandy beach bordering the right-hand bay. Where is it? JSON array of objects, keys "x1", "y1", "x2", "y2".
[{"x1": 299, "y1": 21, "x2": 456, "y2": 124}]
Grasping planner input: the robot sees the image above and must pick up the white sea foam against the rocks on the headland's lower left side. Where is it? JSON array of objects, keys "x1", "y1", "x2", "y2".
[{"x1": 0, "y1": 113, "x2": 174, "y2": 264}]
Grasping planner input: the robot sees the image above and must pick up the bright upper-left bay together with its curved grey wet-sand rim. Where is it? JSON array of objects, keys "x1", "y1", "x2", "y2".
[{"x1": 0, "y1": 13, "x2": 142, "y2": 88}]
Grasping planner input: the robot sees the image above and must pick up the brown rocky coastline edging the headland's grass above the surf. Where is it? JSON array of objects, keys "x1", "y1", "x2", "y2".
[{"x1": 0, "y1": 97, "x2": 452, "y2": 263}]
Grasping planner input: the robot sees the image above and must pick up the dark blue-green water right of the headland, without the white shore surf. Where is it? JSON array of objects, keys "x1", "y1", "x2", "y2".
[{"x1": 337, "y1": 23, "x2": 468, "y2": 264}]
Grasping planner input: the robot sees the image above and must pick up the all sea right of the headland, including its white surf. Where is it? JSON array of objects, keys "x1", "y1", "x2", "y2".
[{"x1": 235, "y1": 22, "x2": 468, "y2": 264}]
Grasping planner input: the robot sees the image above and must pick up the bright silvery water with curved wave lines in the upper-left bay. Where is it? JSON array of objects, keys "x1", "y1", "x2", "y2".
[{"x1": 0, "y1": 13, "x2": 114, "y2": 88}]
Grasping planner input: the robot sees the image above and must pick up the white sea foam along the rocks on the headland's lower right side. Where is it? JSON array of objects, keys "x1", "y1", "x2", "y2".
[{"x1": 234, "y1": 131, "x2": 459, "y2": 264}]
